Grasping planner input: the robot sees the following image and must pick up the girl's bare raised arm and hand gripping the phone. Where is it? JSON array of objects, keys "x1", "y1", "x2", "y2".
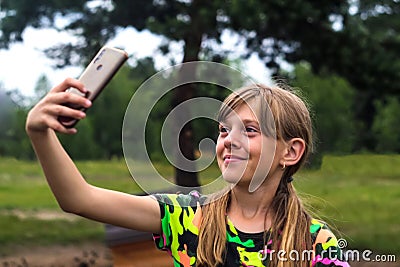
[{"x1": 26, "y1": 78, "x2": 161, "y2": 233}]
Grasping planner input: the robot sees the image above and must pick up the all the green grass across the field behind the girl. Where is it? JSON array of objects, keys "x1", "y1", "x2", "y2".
[{"x1": 0, "y1": 155, "x2": 400, "y2": 255}]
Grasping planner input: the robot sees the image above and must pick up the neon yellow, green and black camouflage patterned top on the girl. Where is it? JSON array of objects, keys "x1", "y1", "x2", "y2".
[{"x1": 153, "y1": 191, "x2": 350, "y2": 267}]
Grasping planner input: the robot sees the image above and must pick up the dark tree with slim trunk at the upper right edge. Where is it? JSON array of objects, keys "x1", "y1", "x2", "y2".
[{"x1": 296, "y1": 0, "x2": 400, "y2": 150}]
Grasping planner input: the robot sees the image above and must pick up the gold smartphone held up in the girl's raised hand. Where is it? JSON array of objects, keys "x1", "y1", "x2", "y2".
[{"x1": 58, "y1": 46, "x2": 128, "y2": 128}]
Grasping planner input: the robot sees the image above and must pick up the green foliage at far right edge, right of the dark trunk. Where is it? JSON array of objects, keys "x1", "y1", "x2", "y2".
[{"x1": 372, "y1": 97, "x2": 400, "y2": 153}]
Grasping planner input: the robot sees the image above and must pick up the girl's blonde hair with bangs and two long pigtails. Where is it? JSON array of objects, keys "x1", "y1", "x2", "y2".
[{"x1": 197, "y1": 84, "x2": 313, "y2": 267}]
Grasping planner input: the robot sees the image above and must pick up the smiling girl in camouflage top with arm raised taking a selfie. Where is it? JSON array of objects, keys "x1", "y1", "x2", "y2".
[{"x1": 26, "y1": 79, "x2": 349, "y2": 266}]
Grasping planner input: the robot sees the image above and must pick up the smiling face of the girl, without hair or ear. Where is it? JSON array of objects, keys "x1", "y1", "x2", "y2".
[{"x1": 216, "y1": 104, "x2": 276, "y2": 188}]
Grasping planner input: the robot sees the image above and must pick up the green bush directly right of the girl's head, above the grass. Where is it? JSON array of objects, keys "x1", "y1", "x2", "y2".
[{"x1": 293, "y1": 64, "x2": 357, "y2": 156}]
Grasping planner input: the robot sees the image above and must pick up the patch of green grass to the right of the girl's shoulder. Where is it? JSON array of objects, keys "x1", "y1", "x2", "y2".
[{"x1": 296, "y1": 155, "x2": 400, "y2": 255}]
